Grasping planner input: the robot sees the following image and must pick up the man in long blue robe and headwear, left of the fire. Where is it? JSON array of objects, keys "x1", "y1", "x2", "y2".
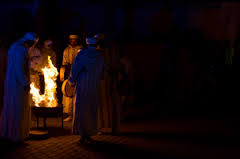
[{"x1": 0, "y1": 33, "x2": 38, "y2": 142}]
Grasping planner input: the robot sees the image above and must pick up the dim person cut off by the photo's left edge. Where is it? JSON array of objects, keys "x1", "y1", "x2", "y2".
[{"x1": 0, "y1": 38, "x2": 8, "y2": 114}]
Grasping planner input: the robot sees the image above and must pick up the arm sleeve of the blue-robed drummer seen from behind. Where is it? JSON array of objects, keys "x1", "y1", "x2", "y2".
[{"x1": 68, "y1": 54, "x2": 84, "y2": 85}]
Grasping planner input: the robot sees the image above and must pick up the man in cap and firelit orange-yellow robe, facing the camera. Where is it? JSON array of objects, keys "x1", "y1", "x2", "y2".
[{"x1": 60, "y1": 35, "x2": 82, "y2": 121}]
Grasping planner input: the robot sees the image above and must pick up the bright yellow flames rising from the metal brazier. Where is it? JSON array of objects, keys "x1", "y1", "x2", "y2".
[{"x1": 30, "y1": 56, "x2": 58, "y2": 107}]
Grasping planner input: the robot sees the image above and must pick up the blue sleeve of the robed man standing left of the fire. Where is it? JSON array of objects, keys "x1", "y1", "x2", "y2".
[{"x1": 15, "y1": 48, "x2": 29, "y2": 86}]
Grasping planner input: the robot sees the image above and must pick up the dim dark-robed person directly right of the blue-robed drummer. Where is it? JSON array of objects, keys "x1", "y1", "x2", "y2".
[{"x1": 96, "y1": 34, "x2": 121, "y2": 134}]
